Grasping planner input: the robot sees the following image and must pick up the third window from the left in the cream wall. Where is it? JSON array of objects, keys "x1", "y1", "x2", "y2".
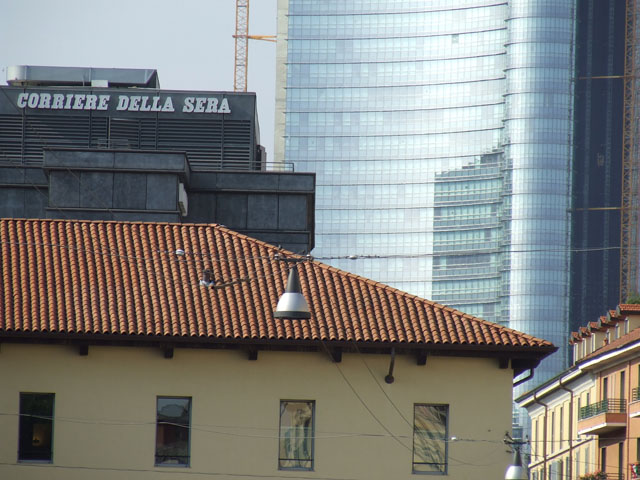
[{"x1": 278, "y1": 400, "x2": 315, "y2": 470}]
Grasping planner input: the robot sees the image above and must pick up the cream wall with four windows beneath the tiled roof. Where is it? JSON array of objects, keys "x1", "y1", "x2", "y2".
[{"x1": 0, "y1": 344, "x2": 512, "y2": 480}]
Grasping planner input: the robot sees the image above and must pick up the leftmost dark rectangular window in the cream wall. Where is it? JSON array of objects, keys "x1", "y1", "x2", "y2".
[{"x1": 18, "y1": 393, "x2": 54, "y2": 462}]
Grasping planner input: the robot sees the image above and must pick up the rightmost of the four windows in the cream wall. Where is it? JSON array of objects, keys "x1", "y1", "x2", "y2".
[{"x1": 413, "y1": 404, "x2": 449, "y2": 475}]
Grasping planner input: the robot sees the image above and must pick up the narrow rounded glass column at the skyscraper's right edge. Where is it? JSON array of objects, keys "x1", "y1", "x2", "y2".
[{"x1": 504, "y1": 0, "x2": 575, "y2": 390}]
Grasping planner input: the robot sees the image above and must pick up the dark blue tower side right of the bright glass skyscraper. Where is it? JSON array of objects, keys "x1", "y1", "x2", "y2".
[{"x1": 570, "y1": 0, "x2": 624, "y2": 331}]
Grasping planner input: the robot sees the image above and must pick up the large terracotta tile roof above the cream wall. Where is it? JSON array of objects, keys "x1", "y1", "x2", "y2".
[{"x1": 0, "y1": 219, "x2": 555, "y2": 357}]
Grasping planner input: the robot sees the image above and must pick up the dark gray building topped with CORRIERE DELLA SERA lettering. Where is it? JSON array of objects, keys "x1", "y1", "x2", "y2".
[{"x1": 0, "y1": 67, "x2": 315, "y2": 252}]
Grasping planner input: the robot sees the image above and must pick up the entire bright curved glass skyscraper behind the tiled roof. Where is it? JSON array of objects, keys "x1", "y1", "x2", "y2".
[{"x1": 276, "y1": 0, "x2": 575, "y2": 390}]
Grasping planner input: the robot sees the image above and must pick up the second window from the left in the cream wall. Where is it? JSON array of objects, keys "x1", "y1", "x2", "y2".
[{"x1": 156, "y1": 397, "x2": 191, "y2": 466}]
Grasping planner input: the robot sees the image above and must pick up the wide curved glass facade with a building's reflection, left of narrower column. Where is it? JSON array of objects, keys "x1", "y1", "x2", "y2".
[{"x1": 281, "y1": 0, "x2": 508, "y2": 321}]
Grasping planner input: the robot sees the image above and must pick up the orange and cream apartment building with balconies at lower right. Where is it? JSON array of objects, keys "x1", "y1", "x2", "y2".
[{"x1": 517, "y1": 304, "x2": 640, "y2": 480}]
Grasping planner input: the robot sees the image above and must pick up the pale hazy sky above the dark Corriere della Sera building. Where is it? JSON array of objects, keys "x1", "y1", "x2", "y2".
[{"x1": 0, "y1": 0, "x2": 276, "y2": 161}]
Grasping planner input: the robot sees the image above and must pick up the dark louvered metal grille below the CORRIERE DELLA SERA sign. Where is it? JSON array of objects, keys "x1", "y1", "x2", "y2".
[{"x1": 0, "y1": 114, "x2": 255, "y2": 171}]
